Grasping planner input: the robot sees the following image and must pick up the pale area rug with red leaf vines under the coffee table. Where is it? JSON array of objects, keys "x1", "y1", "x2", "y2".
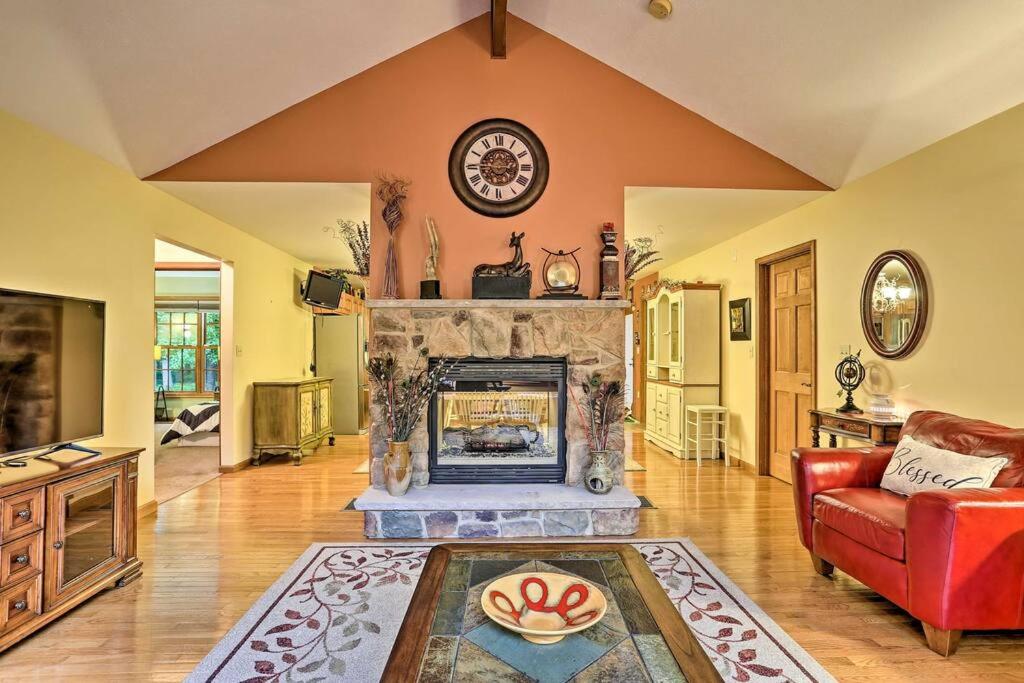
[{"x1": 186, "y1": 539, "x2": 835, "y2": 683}]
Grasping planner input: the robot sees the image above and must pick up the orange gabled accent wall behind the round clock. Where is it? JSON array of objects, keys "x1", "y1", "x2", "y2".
[{"x1": 148, "y1": 14, "x2": 828, "y2": 298}]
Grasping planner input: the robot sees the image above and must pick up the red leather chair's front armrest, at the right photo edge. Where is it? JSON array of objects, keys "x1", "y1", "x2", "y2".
[{"x1": 906, "y1": 487, "x2": 1024, "y2": 630}]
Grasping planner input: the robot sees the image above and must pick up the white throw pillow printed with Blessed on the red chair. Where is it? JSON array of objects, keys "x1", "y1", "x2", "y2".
[{"x1": 882, "y1": 436, "x2": 1010, "y2": 496}]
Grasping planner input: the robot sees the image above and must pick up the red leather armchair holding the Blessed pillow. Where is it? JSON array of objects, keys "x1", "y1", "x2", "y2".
[{"x1": 792, "y1": 411, "x2": 1024, "y2": 656}]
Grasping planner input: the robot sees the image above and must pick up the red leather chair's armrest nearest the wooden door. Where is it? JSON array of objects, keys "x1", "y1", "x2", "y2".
[{"x1": 791, "y1": 446, "x2": 895, "y2": 550}]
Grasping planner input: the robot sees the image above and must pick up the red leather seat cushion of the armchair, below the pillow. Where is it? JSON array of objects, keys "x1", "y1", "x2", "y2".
[{"x1": 814, "y1": 488, "x2": 907, "y2": 561}]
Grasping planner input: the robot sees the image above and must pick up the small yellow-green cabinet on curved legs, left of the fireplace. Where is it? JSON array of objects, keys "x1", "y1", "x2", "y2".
[{"x1": 252, "y1": 377, "x2": 334, "y2": 465}]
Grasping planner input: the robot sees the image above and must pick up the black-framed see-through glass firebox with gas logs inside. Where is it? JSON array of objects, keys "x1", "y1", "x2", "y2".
[{"x1": 427, "y1": 358, "x2": 566, "y2": 483}]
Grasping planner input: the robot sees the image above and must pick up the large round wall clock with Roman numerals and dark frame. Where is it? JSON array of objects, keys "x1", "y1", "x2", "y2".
[{"x1": 449, "y1": 119, "x2": 548, "y2": 217}]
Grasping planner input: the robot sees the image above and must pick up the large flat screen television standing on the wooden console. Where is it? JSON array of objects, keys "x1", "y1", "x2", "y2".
[{"x1": 0, "y1": 289, "x2": 106, "y2": 455}]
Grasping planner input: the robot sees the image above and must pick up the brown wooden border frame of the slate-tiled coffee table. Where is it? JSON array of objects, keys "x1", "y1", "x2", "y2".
[{"x1": 381, "y1": 543, "x2": 723, "y2": 683}]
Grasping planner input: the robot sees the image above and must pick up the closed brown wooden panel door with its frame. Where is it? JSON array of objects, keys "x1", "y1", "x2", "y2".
[{"x1": 756, "y1": 241, "x2": 817, "y2": 483}]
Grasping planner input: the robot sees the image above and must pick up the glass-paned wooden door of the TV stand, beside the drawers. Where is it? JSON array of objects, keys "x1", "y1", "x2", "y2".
[{"x1": 45, "y1": 465, "x2": 127, "y2": 609}]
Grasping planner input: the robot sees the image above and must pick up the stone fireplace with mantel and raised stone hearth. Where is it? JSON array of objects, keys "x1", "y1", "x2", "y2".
[{"x1": 355, "y1": 300, "x2": 639, "y2": 538}]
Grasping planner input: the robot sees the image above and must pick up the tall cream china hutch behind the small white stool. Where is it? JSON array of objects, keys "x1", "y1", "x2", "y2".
[{"x1": 644, "y1": 283, "x2": 722, "y2": 458}]
